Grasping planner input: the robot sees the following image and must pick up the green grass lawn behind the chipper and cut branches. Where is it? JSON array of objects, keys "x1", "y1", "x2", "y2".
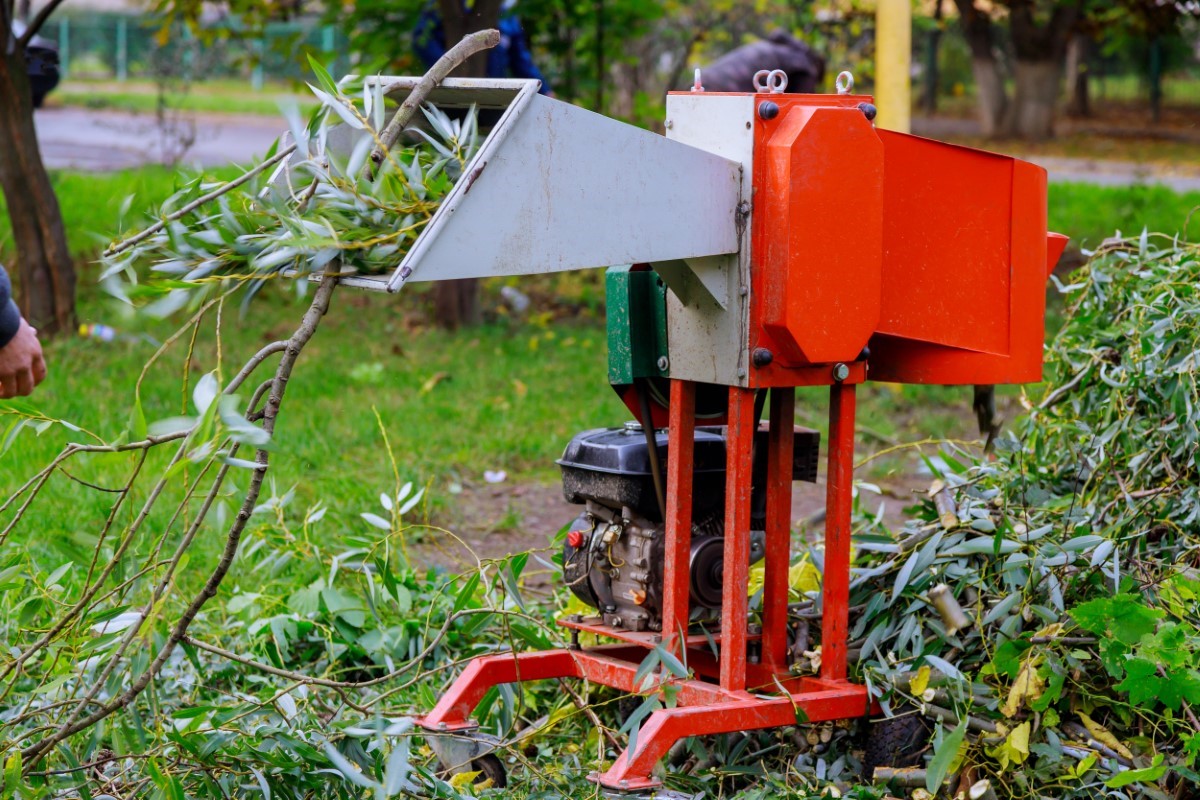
[{"x1": 0, "y1": 168, "x2": 1200, "y2": 563}]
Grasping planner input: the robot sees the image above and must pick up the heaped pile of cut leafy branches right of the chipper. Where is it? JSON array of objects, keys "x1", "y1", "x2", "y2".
[{"x1": 851, "y1": 234, "x2": 1200, "y2": 798}]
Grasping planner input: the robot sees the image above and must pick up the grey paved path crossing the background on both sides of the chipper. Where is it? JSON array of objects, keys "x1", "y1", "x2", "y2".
[{"x1": 36, "y1": 108, "x2": 1200, "y2": 192}]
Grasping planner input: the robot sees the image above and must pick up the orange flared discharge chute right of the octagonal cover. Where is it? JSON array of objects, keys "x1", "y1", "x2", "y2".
[{"x1": 869, "y1": 143, "x2": 1050, "y2": 384}]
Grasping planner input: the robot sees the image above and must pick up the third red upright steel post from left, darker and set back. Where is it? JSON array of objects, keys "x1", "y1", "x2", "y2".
[{"x1": 762, "y1": 387, "x2": 796, "y2": 672}]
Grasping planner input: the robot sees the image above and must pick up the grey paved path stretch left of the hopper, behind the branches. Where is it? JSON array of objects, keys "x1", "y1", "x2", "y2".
[{"x1": 35, "y1": 108, "x2": 287, "y2": 172}]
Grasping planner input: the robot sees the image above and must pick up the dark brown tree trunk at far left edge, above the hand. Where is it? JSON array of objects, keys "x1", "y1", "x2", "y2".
[{"x1": 0, "y1": 43, "x2": 76, "y2": 335}]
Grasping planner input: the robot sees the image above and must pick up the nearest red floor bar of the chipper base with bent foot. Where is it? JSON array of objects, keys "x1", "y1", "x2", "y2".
[{"x1": 595, "y1": 684, "x2": 869, "y2": 789}]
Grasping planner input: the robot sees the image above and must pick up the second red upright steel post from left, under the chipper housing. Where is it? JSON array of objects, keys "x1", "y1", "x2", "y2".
[{"x1": 721, "y1": 386, "x2": 757, "y2": 690}]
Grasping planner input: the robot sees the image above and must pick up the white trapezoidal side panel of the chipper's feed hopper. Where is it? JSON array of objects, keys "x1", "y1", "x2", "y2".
[{"x1": 389, "y1": 95, "x2": 740, "y2": 291}]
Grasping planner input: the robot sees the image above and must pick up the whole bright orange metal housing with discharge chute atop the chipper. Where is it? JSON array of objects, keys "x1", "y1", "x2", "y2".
[{"x1": 748, "y1": 95, "x2": 1066, "y2": 386}]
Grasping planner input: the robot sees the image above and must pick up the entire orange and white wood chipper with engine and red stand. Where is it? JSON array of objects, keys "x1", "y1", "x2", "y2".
[{"x1": 304, "y1": 73, "x2": 1066, "y2": 792}]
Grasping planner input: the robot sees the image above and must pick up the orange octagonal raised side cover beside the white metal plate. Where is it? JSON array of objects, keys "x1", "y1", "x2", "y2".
[{"x1": 750, "y1": 100, "x2": 883, "y2": 367}]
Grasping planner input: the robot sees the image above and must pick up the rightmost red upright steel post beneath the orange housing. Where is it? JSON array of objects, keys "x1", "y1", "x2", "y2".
[{"x1": 821, "y1": 384, "x2": 854, "y2": 680}]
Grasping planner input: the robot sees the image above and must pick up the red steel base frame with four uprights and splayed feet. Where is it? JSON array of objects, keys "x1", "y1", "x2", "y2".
[{"x1": 418, "y1": 377, "x2": 875, "y2": 790}]
